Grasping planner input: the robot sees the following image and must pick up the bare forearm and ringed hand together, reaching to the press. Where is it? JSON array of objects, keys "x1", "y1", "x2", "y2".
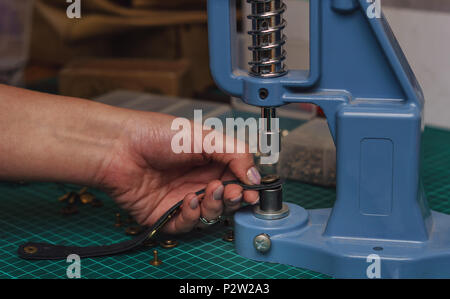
[{"x1": 0, "y1": 85, "x2": 260, "y2": 233}]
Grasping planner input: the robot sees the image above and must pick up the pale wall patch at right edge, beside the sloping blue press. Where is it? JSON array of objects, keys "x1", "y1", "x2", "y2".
[{"x1": 384, "y1": 8, "x2": 450, "y2": 129}]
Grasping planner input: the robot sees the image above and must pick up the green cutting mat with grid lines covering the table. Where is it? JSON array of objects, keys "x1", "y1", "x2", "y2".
[{"x1": 0, "y1": 128, "x2": 450, "y2": 278}]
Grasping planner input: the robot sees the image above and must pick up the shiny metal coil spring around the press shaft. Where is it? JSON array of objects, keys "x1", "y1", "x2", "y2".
[{"x1": 247, "y1": 0, "x2": 287, "y2": 78}]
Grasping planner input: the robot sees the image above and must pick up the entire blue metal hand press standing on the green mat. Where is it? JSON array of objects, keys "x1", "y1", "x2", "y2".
[{"x1": 208, "y1": 0, "x2": 450, "y2": 278}]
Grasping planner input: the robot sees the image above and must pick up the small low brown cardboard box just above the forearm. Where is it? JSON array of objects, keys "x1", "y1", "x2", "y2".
[{"x1": 59, "y1": 58, "x2": 193, "y2": 99}]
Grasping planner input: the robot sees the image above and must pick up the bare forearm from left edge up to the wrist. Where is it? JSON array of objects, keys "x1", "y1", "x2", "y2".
[{"x1": 0, "y1": 86, "x2": 127, "y2": 185}]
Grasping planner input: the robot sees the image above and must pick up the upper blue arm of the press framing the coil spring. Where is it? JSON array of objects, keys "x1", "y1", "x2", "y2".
[{"x1": 208, "y1": 0, "x2": 423, "y2": 138}]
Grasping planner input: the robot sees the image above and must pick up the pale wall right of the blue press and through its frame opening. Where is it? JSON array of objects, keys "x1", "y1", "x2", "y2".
[{"x1": 240, "y1": 0, "x2": 450, "y2": 129}]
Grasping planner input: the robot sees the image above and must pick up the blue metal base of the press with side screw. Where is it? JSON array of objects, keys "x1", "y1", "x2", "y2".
[{"x1": 235, "y1": 203, "x2": 450, "y2": 278}]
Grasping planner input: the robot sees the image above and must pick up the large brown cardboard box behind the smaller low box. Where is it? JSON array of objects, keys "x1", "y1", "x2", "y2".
[{"x1": 31, "y1": 0, "x2": 214, "y2": 96}]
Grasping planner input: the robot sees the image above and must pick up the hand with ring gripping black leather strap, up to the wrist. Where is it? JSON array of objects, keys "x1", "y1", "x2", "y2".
[{"x1": 98, "y1": 113, "x2": 261, "y2": 233}]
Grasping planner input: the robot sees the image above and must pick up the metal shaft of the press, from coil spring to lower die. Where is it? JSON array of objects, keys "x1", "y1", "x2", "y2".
[{"x1": 247, "y1": 0, "x2": 289, "y2": 219}]
